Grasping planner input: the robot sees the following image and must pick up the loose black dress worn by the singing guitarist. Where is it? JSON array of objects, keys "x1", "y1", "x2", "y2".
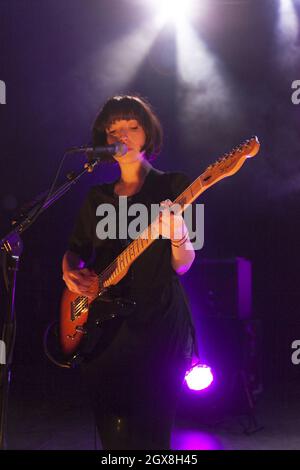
[{"x1": 69, "y1": 168, "x2": 194, "y2": 450}]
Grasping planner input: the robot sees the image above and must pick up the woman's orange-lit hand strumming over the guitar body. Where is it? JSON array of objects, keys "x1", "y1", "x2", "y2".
[{"x1": 63, "y1": 268, "x2": 99, "y2": 300}]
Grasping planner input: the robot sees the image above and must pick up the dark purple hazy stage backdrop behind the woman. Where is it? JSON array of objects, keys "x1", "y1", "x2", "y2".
[{"x1": 0, "y1": 0, "x2": 300, "y2": 434}]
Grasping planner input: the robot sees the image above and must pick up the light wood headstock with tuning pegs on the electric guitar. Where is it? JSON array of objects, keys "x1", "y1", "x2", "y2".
[{"x1": 201, "y1": 136, "x2": 260, "y2": 186}]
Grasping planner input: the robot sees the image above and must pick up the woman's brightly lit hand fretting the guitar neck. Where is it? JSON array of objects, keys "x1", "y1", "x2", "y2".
[{"x1": 159, "y1": 199, "x2": 188, "y2": 243}]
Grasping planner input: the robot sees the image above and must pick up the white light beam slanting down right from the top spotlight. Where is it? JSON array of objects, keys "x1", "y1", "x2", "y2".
[{"x1": 176, "y1": 21, "x2": 236, "y2": 145}]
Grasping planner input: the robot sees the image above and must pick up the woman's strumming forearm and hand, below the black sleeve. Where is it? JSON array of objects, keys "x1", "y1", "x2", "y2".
[{"x1": 62, "y1": 250, "x2": 99, "y2": 300}]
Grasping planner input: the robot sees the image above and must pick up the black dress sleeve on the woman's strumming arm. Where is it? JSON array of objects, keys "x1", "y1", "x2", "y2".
[{"x1": 68, "y1": 190, "x2": 95, "y2": 262}]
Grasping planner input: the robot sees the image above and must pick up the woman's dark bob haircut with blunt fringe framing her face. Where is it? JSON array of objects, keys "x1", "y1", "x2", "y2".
[{"x1": 92, "y1": 95, "x2": 163, "y2": 163}]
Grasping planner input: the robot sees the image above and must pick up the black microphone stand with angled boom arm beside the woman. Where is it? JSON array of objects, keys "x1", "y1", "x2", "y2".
[{"x1": 0, "y1": 158, "x2": 101, "y2": 449}]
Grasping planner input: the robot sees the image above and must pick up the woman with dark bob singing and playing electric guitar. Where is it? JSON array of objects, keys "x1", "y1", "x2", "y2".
[{"x1": 63, "y1": 95, "x2": 195, "y2": 450}]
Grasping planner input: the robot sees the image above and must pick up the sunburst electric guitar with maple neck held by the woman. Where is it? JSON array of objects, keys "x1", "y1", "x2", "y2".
[{"x1": 59, "y1": 137, "x2": 260, "y2": 363}]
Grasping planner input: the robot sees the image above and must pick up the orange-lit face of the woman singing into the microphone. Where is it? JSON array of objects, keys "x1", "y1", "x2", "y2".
[{"x1": 106, "y1": 119, "x2": 146, "y2": 158}]
